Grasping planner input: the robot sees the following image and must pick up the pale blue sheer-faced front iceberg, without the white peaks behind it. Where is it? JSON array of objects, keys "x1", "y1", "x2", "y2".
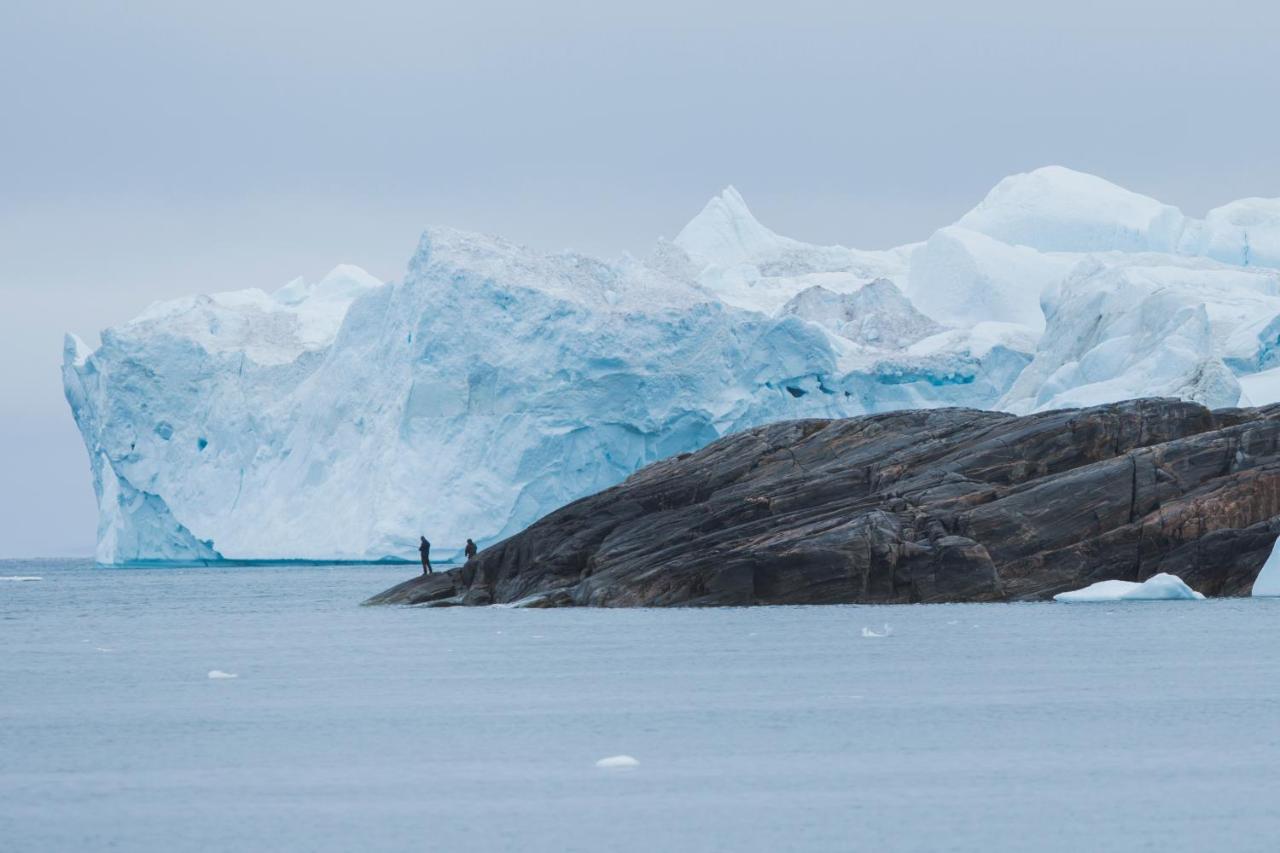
[{"x1": 64, "y1": 228, "x2": 1008, "y2": 564}]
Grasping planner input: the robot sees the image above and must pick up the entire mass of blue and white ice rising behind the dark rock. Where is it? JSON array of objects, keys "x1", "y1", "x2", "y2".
[{"x1": 63, "y1": 167, "x2": 1280, "y2": 564}]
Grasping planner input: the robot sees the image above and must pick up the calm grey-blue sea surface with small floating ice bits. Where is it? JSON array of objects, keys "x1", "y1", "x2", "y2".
[{"x1": 0, "y1": 561, "x2": 1280, "y2": 853}]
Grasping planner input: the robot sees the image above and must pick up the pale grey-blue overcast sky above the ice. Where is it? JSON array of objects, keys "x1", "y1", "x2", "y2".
[{"x1": 0, "y1": 0, "x2": 1280, "y2": 557}]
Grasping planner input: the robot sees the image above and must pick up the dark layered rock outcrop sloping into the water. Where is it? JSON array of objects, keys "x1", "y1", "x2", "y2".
[{"x1": 369, "y1": 400, "x2": 1280, "y2": 607}]
